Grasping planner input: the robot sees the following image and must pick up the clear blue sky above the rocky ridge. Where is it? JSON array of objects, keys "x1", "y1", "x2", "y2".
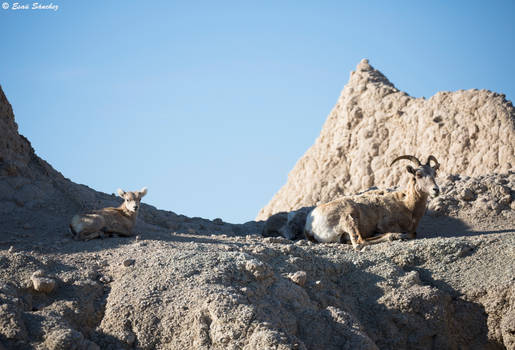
[{"x1": 0, "y1": 0, "x2": 515, "y2": 222}]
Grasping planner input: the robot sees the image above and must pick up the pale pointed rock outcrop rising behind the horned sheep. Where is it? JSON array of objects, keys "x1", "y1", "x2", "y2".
[{"x1": 257, "y1": 60, "x2": 515, "y2": 220}]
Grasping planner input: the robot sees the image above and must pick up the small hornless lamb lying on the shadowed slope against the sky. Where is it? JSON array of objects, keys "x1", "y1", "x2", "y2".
[{"x1": 70, "y1": 187, "x2": 147, "y2": 241}]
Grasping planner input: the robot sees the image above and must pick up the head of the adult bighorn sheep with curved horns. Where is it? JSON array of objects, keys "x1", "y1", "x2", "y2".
[{"x1": 390, "y1": 155, "x2": 440, "y2": 197}]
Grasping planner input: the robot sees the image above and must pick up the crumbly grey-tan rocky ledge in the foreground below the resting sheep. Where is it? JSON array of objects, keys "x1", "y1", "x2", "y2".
[{"x1": 0, "y1": 226, "x2": 515, "y2": 350}]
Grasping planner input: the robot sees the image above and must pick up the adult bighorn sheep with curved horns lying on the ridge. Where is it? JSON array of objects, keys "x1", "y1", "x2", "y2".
[{"x1": 304, "y1": 155, "x2": 440, "y2": 249}]
